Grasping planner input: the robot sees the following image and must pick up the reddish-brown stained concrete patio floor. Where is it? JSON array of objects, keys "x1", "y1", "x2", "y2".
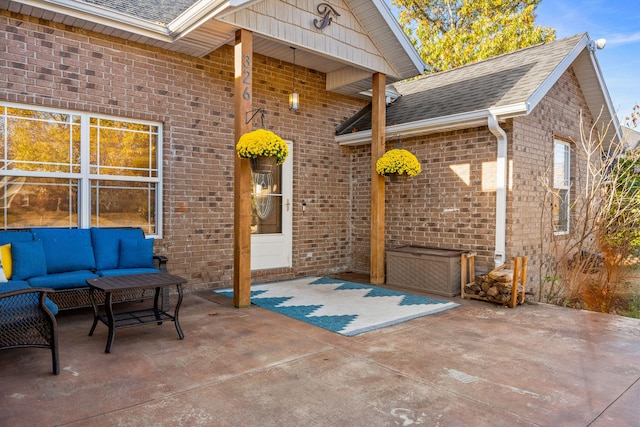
[{"x1": 0, "y1": 282, "x2": 640, "y2": 427}]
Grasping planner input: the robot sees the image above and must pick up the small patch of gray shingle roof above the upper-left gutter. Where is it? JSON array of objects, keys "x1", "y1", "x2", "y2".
[{"x1": 76, "y1": 0, "x2": 197, "y2": 25}]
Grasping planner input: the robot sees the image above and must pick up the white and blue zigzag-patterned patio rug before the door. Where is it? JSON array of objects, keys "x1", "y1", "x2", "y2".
[{"x1": 214, "y1": 277, "x2": 460, "y2": 336}]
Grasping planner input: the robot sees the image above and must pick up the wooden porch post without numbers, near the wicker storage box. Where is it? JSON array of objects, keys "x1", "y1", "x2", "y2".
[{"x1": 369, "y1": 73, "x2": 387, "y2": 285}]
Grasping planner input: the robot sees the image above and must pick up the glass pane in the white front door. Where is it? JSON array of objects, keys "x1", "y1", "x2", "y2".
[{"x1": 251, "y1": 166, "x2": 282, "y2": 234}]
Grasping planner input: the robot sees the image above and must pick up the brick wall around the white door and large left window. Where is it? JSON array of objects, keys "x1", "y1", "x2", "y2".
[{"x1": 0, "y1": 11, "x2": 364, "y2": 288}]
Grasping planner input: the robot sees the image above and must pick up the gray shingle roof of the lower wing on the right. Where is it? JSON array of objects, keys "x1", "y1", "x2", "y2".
[{"x1": 336, "y1": 34, "x2": 584, "y2": 135}]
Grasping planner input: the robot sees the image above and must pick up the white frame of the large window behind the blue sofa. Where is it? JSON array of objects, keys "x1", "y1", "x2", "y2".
[{"x1": 0, "y1": 102, "x2": 163, "y2": 238}]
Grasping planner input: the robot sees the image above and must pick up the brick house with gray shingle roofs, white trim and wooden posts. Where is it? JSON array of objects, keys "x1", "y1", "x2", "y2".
[{"x1": 0, "y1": 0, "x2": 612, "y2": 298}]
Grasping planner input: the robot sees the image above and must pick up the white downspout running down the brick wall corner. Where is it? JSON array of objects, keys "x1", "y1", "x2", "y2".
[{"x1": 487, "y1": 111, "x2": 507, "y2": 267}]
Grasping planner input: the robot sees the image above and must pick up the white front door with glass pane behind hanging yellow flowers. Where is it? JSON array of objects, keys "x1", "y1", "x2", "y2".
[{"x1": 251, "y1": 141, "x2": 293, "y2": 270}]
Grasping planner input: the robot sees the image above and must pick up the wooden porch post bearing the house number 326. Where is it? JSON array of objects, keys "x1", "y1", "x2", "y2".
[{"x1": 233, "y1": 30, "x2": 253, "y2": 307}]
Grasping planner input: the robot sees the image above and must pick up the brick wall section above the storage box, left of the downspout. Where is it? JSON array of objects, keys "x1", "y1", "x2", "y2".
[{"x1": 351, "y1": 128, "x2": 497, "y2": 272}]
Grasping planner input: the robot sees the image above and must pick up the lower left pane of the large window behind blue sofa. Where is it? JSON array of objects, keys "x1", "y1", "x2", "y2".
[{"x1": 0, "y1": 176, "x2": 78, "y2": 228}]
